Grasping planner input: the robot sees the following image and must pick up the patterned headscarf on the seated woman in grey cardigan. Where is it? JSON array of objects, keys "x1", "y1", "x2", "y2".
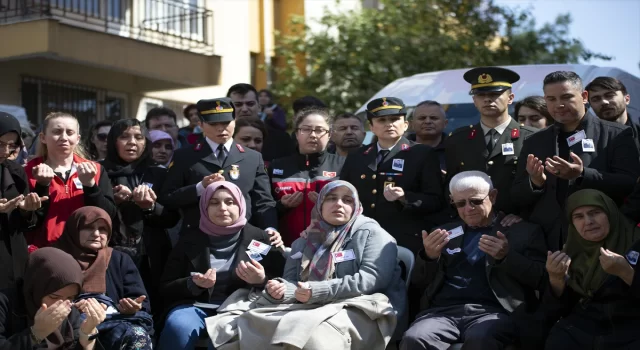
[{"x1": 300, "y1": 180, "x2": 362, "y2": 282}]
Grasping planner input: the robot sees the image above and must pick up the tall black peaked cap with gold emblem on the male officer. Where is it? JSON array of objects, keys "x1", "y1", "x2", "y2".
[{"x1": 464, "y1": 67, "x2": 520, "y2": 95}]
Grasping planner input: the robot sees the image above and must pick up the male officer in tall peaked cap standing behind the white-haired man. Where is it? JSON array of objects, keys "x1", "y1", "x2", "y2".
[{"x1": 445, "y1": 67, "x2": 537, "y2": 214}]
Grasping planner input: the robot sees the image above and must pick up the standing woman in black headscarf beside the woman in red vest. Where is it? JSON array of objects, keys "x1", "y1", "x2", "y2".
[{"x1": 104, "y1": 119, "x2": 179, "y2": 309}]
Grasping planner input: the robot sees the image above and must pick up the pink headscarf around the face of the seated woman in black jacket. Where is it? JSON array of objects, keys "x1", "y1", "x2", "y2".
[{"x1": 200, "y1": 181, "x2": 247, "y2": 236}]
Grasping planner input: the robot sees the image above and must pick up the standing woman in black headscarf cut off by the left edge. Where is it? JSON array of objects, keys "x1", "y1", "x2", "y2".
[{"x1": 0, "y1": 112, "x2": 48, "y2": 289}]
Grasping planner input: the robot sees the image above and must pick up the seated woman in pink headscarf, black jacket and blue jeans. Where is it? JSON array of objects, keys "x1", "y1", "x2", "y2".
[{"x1": 158, "y1": 181, "x2": 284, "y2": 350}]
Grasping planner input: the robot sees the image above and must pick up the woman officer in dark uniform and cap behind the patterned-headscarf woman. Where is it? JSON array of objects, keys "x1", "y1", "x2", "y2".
[{"x1": 340, "y1": 97, "x2": 444, "y2": 252}]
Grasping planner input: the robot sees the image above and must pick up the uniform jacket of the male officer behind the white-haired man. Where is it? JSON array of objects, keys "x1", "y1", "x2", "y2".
[{"x1": 445, "y1": 119, "x2": 538, "y2": 214}]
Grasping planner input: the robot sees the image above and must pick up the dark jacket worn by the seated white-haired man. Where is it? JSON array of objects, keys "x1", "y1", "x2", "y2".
[{"x1": 411, "y1": 221, "x2": 547, "y2": 312}]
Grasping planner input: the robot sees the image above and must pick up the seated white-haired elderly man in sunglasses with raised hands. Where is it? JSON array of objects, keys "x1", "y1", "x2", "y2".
[{"x1": 400, "y1": 171, "x2": 547, "y2": 350}]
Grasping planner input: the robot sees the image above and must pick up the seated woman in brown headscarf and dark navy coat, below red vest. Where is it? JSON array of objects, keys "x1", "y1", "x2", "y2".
[{"x1": 54, "y1": 207, "x2": 153, "y2": 350}]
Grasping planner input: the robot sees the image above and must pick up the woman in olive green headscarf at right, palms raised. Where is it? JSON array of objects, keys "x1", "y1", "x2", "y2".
[{"x1": 542, "y1": 189, "x2": 640, "y2": 350}]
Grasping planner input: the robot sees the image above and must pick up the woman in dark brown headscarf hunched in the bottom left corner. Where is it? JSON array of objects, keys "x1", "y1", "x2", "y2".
[{"x1": 0, "y1": 247, "x2": 105, "y2": 350}]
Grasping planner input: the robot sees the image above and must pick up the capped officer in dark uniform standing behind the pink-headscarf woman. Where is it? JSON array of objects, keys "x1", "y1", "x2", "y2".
[{"x1": 160, "y1": 98, "x2": 278, "y2": 229}]
